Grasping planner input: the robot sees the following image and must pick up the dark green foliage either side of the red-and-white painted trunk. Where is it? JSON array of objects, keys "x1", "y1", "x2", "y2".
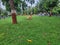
[{"x1": 2, "y1": 0, "x2": 27, "y2": 11}]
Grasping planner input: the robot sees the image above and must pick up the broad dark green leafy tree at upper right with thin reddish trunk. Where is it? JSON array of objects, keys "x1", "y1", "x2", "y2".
[{"x1": 37, "y1": 0, "x2": 58, "y2": 16}]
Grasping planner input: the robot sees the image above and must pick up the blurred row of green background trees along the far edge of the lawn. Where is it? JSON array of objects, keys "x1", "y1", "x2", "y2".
[{"x1": 2, "y1": 0, "x2": 59, "y2": 14}]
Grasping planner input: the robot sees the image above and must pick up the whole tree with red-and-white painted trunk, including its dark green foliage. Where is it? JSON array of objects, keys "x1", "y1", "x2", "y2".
[{"x1": 2, "y1": 0, "x2": 26, "y2": 24}]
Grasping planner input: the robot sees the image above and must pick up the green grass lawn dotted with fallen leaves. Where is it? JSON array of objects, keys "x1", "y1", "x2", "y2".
[{"x1": 0, "y1": 16, "x2": 60, "y2": 45}]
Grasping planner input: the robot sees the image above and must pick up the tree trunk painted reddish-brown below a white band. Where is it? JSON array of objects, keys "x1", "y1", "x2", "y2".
[{"x1": 9, "y1": 0, "x2": 17, "y2": 24}]
